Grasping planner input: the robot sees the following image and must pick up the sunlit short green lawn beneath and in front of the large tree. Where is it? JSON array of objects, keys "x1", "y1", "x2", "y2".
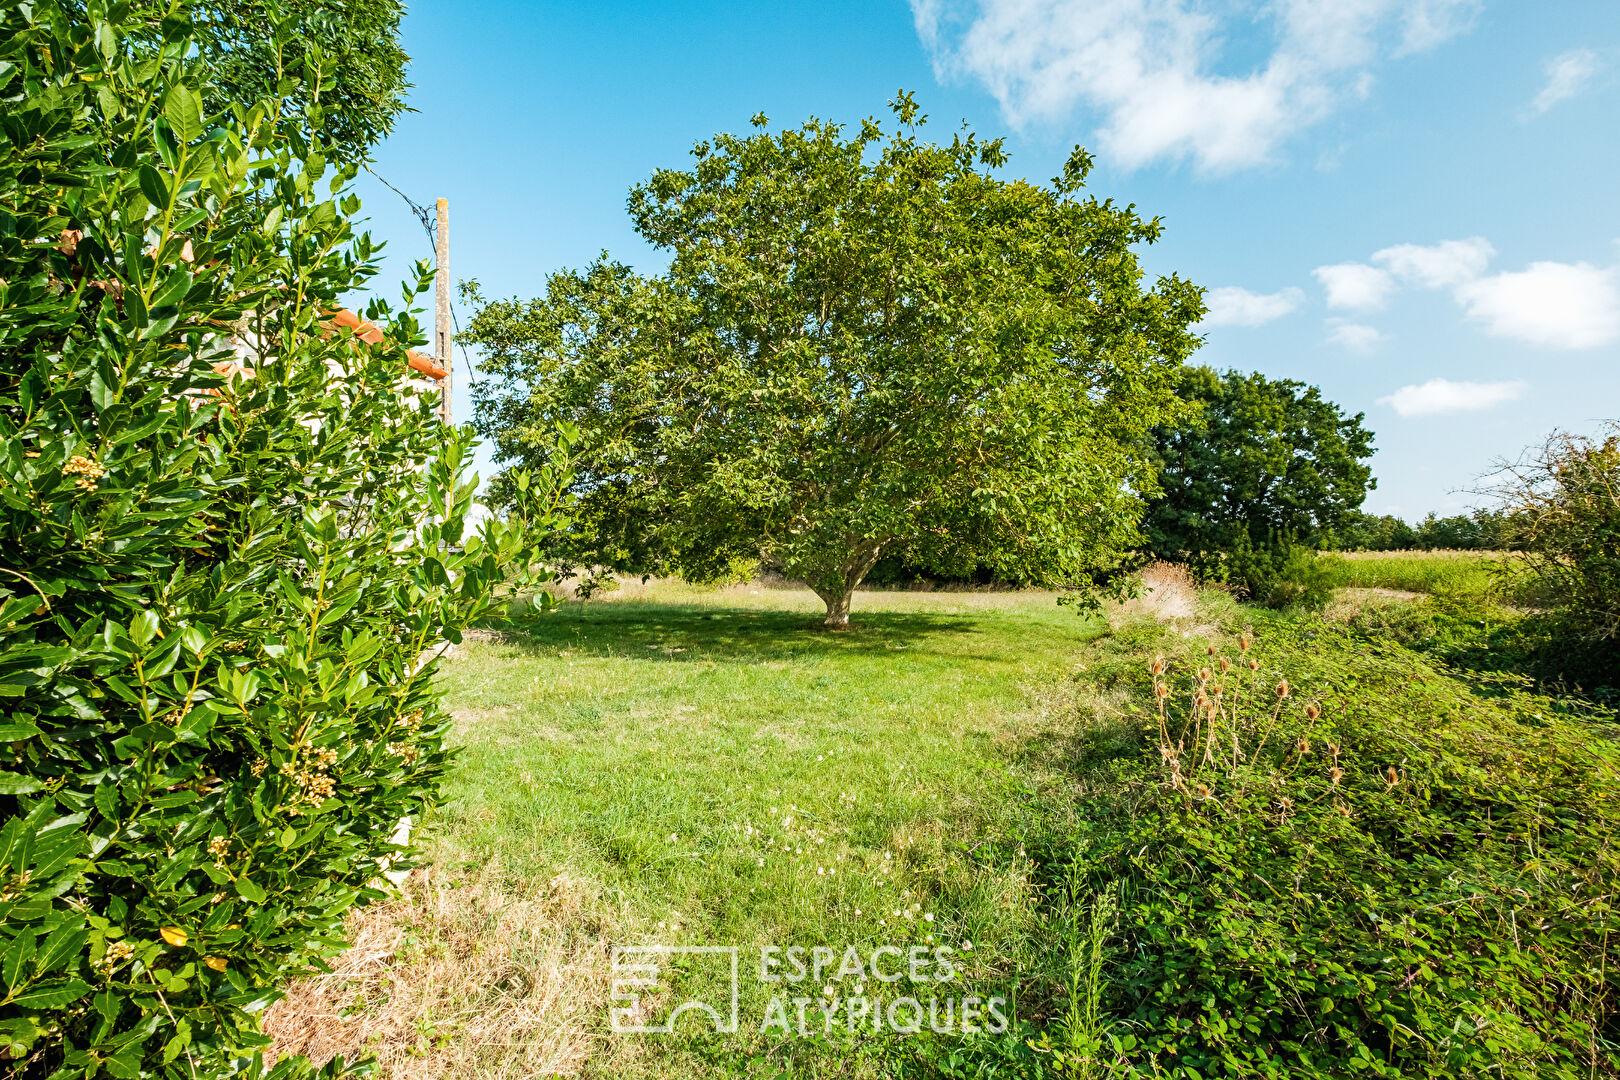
[{"x1": 423, "y1": 586, "x2": 1105, "y2": 1075}]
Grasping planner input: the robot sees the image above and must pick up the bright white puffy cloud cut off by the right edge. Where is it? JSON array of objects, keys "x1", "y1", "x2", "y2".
[{"x1": 1453, "y1": 262, "x2": 1620, "y2": 348}]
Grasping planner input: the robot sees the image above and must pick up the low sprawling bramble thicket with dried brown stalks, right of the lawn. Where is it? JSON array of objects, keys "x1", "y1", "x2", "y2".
[{"x1": 1074, "y1": 622, "x2": 1620, "y2": 1080}]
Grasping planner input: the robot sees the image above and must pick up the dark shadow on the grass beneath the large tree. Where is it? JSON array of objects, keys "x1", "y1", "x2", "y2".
[{"x1": 492, "y1": 601, "x2": 984, "y2": 664}]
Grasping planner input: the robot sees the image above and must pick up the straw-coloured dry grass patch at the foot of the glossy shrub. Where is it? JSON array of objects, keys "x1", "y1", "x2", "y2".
[{"x1": 264, "y1": 866, "x2": 616, "y2": 1080}]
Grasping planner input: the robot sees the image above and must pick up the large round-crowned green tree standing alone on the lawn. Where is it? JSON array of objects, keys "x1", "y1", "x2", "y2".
[{"x1": 465, "y1": 94, "x2": 1204, "y2": 627}]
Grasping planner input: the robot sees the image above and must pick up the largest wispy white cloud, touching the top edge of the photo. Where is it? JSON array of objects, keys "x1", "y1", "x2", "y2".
[{"x1": 910, "y1": 0, "x2": 1477, "y2": 172}]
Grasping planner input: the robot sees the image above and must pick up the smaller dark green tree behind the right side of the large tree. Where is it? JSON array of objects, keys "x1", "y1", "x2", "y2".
[{"x1": 1144, "y1": 368, "x2": 1375, "y2": 568}]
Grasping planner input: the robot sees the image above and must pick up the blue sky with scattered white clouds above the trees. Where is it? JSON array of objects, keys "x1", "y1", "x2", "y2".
[{"x1": 360, "y1": 0, "x2": 1620, "y2": 518}]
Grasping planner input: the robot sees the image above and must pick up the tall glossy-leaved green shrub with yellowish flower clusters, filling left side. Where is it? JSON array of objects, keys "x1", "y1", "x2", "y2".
[{"x1": 0, "y1": 0, "x2": 557, "y2": 1077}]
